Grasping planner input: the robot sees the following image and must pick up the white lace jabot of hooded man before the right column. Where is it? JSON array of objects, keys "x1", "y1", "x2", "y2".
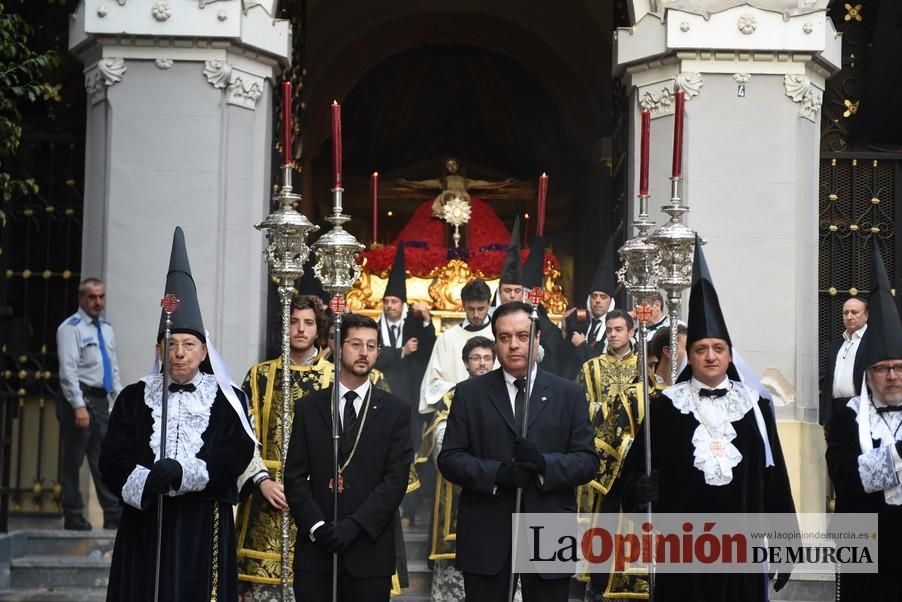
[{"x1": 664, "y1": 379, "x2": 769, "y2": 486}]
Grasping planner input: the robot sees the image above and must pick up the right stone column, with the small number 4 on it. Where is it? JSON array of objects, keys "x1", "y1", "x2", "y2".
[{"x1": 615, "y1": 0, "x2": 841, "y2": 511}]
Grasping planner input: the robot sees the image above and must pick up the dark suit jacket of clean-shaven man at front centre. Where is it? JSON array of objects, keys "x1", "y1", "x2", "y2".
[{"x1": 438, "y1": 369, "x2": 598, "y2": 578}]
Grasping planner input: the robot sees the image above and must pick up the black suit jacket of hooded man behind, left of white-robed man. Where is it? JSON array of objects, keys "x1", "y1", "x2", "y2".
[{"x1": 376, "y1": 311, "x2": 435, "y2": 408}]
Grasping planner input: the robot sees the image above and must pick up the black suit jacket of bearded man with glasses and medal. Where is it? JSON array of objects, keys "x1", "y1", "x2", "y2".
[{"x1": 285, "y1": 387, "x2": 413, "y2": 577}]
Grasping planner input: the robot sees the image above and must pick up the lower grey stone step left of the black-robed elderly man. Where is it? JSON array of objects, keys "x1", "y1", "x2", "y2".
[{"x1": 9, "y1": 555, "x2": 110, "y2": 590}]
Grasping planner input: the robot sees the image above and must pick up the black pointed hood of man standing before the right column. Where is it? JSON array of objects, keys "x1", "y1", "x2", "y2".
[{"x1": 677, "y1": 235, "x2": 742, "y2": 382}]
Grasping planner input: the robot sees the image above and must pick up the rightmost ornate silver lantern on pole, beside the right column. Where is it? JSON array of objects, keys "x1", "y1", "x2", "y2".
[{"x1": 649, "y1": 177, "x2": 695, "y2": 383}]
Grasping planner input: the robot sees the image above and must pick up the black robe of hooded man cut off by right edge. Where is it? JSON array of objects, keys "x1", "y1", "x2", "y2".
[{"x1": 826, "y1": 397, "x2": 902, "y2": 602}]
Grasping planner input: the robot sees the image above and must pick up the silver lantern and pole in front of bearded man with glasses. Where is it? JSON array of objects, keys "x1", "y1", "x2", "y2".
[{"x1": 313, "y1": 187, "x2": 364, "y2": 602}]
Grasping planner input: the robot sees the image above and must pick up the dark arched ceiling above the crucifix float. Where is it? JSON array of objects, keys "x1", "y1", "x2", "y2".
[{"x1": 304, "y1": 0, "x2": 613, "y2": 152}]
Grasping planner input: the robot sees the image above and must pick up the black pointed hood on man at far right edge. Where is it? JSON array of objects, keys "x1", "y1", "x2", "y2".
[{"x1": 856, "y1": 237, "x2": 902, "y2": 366}]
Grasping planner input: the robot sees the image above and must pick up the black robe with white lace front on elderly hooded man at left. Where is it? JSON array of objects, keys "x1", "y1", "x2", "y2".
[{"x1": 100, "y1": 374, "x2": 254, "y2": 602}]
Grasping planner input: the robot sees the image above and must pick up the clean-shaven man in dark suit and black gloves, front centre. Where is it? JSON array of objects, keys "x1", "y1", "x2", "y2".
[{"x1": 438, "y1": 301, "x2": 598, "y2": 602}]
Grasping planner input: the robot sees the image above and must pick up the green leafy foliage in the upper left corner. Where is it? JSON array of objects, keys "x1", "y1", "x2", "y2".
[{"x1": 0, "y1": 2, "x2": 60, "y2": 205}]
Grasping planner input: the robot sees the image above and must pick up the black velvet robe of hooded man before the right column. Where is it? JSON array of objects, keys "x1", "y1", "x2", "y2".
[{"x1": 622, "y1": 383, "x2": 798, "y2": 602}]
